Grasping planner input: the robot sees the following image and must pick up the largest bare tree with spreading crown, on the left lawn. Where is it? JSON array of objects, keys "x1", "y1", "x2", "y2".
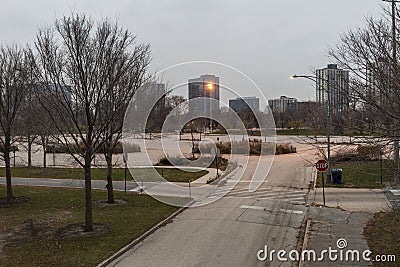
[{"x1": 35, "y1": 14, "x2": 148, "y2": 231}]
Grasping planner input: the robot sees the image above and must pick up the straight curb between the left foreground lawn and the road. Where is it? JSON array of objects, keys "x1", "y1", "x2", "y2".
[{"x1": 97, "y1": 200, "x2": 194, "y2": 267}]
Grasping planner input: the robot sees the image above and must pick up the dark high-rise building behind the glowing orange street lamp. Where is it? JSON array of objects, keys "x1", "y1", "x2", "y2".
[{"x1": 188, "y1": 74, "x2": 219, "y2": 117}]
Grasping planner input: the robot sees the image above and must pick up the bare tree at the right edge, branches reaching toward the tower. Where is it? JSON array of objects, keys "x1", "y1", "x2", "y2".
[{"x1": 329, "y1": 6, "x2": 400, "y2": 182}]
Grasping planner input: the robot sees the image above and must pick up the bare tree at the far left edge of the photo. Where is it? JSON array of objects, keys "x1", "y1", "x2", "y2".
[{"x1": 0, "y1": 46, "x2": 28, "y2": 200}]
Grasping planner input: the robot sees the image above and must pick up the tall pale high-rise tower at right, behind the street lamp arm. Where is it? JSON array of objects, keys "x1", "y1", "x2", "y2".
[{"x1": 316, "y1": 64, "x2": 350, "y2": 115}]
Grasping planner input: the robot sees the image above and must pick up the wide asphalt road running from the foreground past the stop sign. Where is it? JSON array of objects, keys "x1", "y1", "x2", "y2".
[{"x1": 110, "y1": 141, "x2": 314, "y2": 266}]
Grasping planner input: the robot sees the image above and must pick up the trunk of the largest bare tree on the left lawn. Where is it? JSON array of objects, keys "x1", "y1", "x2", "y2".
[{"x1": 84, "y1": 155, "x2": 93, "y2": 232}]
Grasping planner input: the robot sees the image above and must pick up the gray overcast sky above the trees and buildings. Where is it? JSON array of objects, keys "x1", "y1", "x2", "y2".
[{"x1": 0, "y1": 0, "x2": 382, "y2": 106}]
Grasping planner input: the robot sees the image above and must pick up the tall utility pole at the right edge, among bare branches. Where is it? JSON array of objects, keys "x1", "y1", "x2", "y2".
[{"x1": 382, "y1": 0, "x2": 400, "y2": 184}]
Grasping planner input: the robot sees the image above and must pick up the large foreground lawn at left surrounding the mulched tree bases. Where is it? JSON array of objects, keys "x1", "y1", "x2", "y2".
[{"x1": 0, "y1": 186, "x2": 183, "y2": 266}]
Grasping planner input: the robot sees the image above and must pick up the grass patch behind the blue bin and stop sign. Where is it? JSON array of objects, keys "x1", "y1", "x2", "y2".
[{"x1": 317, "y1": 161, "x2": 392, "y2": 188}]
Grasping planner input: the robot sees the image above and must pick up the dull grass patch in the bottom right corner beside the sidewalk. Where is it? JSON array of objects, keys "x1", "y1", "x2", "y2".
[{"x1": 364, "y1": 211, "x2": 400, "y2": 266}]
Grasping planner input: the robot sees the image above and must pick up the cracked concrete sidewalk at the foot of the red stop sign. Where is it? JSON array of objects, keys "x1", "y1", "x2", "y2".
[{"x1": 302, "y1": 188, "x2": 390, "y2": 266}]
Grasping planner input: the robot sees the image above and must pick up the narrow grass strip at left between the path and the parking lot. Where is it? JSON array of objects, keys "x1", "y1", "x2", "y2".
[{"x1": 0, "y1": 167, "x2": 208, "y2": 182}]
